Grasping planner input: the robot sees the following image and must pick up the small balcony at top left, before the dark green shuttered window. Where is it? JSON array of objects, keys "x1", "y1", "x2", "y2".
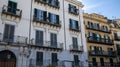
[{"x1": 2, "y1": 5, "x2": 22, "y2": 18}]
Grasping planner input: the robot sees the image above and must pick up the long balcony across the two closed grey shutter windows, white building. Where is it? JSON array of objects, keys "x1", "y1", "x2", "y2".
[{"x1": 30, "y1": 39, "x2": 63, "y2": 51}]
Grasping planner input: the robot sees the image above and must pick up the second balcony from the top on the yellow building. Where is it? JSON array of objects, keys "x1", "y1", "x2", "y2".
[{"x1": 87, "y1": 37, "x2": 114, "y2": 45}]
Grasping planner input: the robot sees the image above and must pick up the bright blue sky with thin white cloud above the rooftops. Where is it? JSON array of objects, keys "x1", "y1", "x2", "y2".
[{"x1": 79, "y1": 0, "x2": 120, "y2": 19}]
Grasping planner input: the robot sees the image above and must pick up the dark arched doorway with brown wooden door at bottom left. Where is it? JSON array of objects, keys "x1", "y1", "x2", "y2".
[{"x1": 0, "y1": 50, "x2": 16, "y2": 67}]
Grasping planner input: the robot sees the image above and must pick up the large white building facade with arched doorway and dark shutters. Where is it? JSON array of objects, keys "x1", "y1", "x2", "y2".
[{"x1": 0, "y1": 0, "x2": 88, "y2": 67}]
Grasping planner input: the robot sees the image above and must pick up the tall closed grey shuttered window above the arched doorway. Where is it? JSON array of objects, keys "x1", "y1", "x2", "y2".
[{"x1": 3, "y1": 24, "x2": 15, "y2": 42}]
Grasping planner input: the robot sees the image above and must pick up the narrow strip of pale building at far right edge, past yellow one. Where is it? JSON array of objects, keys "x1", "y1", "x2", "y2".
[{"x1": 109, "y1": 19, "x2": 120, "y2": 64}]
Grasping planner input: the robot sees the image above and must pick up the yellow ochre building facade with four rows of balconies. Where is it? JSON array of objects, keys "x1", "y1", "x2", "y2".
[{"x1": 84, "y1": 13, "x2": 116, "y2": 67}]
